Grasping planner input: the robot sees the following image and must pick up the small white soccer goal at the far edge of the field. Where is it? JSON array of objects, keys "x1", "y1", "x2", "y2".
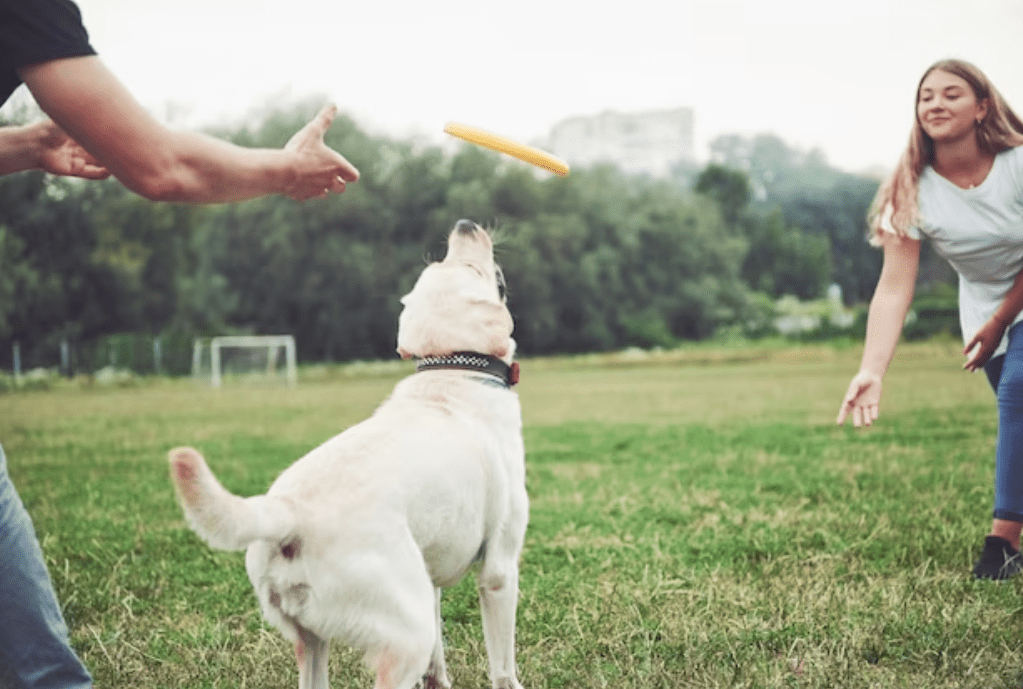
[{"x1": 192, "y1": 335, "x2": 299, "y2": 387}]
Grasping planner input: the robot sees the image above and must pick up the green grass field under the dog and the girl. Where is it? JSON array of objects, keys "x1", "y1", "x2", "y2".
[{"x1": 0, "y1": 341, "x2": 1023, "y2": 689}]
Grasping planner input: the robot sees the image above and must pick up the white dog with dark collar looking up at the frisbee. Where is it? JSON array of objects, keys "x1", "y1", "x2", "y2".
[{"x1": 170, "y1": 220, "x2": 529, "y2": 689}]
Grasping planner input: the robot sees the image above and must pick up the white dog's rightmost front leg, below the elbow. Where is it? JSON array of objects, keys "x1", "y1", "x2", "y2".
[{"x1": 479, "y1": 564, "x2": 522, "y2": 689}]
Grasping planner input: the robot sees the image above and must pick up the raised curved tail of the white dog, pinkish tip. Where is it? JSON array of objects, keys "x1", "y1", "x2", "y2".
[{"x1": 168, "y1": 448, "x2": 298, "y2": 550}]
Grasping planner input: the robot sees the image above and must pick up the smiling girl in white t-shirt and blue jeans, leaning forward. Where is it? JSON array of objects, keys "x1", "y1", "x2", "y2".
[{"x1": 838, "y1": 59, "x2": 1023, "y2": 579}]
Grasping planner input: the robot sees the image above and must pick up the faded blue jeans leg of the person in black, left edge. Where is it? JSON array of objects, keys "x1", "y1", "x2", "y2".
[{"x1": 0, "y1": 448, "x2": 92, "y2": 689}]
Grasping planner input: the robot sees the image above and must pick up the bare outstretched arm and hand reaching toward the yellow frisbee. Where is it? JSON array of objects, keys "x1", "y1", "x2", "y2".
[{"x1": 20, "y1": 56, "x2": 359, "y2": 202}]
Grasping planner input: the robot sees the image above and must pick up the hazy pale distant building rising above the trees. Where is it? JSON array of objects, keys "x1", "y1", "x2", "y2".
[{"x1": 549, "y1": 107, "x2": 696, "y2": 178}]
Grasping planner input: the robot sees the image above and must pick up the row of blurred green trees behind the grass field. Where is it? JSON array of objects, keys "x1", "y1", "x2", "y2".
[{"x1": 0, "y1": 99, "x2": 904, "y2": 370}]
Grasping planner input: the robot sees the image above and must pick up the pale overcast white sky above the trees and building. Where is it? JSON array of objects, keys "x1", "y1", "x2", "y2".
[{"x1": 7, "y1": 0, "x2": 1023, "y2": 171}]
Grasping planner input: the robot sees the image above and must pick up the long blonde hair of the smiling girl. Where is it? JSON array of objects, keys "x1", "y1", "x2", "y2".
[{"x1": 868, "y1": 59, "x2": 1023, "y2": 245}]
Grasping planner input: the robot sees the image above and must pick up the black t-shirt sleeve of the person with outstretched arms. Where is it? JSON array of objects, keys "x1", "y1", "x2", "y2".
[{"x1": 0, "y1": 0, "x2": 96, "y2": 103}]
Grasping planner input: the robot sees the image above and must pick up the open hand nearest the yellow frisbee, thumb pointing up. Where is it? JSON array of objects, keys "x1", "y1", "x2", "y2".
[{"x1": 284, "y1": 105, "x2": 359, "y2": 201}]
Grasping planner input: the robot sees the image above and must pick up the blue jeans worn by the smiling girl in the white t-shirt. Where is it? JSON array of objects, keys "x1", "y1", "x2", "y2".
[{"x1": 984, "y1": 323, "x2": 1023, "y2": 521}]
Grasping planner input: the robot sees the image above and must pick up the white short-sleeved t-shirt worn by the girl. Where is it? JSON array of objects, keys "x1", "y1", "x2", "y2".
[{"x1": 908, "y1": 146, "x2": 1023, "y2": 356}]
